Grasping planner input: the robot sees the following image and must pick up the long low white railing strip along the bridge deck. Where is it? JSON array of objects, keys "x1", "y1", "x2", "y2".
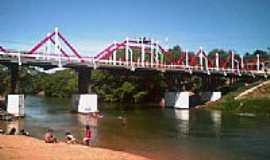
[{"x1": 0, "y1": 50, "x2": 266, "y2": 76}]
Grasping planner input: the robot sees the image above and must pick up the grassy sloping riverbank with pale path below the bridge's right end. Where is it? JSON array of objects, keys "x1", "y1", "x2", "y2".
[{"x1": 205, "y1": 81, "x2": 270, "y2": 115}]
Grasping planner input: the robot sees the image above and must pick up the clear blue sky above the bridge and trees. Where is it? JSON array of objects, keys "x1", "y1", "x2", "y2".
[{"x1": 0, "y1": 0, "x2": 270, "y2": 55}]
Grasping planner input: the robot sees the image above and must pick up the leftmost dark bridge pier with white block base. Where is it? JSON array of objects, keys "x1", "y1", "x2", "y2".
[{"x1": 7, "y1": 64, "x2": 24, "y2": 117}]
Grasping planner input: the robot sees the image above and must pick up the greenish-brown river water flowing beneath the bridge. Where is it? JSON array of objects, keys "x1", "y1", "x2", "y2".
[{"x1": 0, "y1": 96, "x2": 270, "y2": 160}]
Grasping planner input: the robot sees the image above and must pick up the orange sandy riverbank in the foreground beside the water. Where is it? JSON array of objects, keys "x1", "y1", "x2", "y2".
[{"x1": 0, "y1": 135, "x2": 152, "y2": 160}]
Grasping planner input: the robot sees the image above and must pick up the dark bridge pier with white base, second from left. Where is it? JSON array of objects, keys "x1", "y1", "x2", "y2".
[{"x1": 72, "y1": 67, "x2": 98, "y2": 114}]
